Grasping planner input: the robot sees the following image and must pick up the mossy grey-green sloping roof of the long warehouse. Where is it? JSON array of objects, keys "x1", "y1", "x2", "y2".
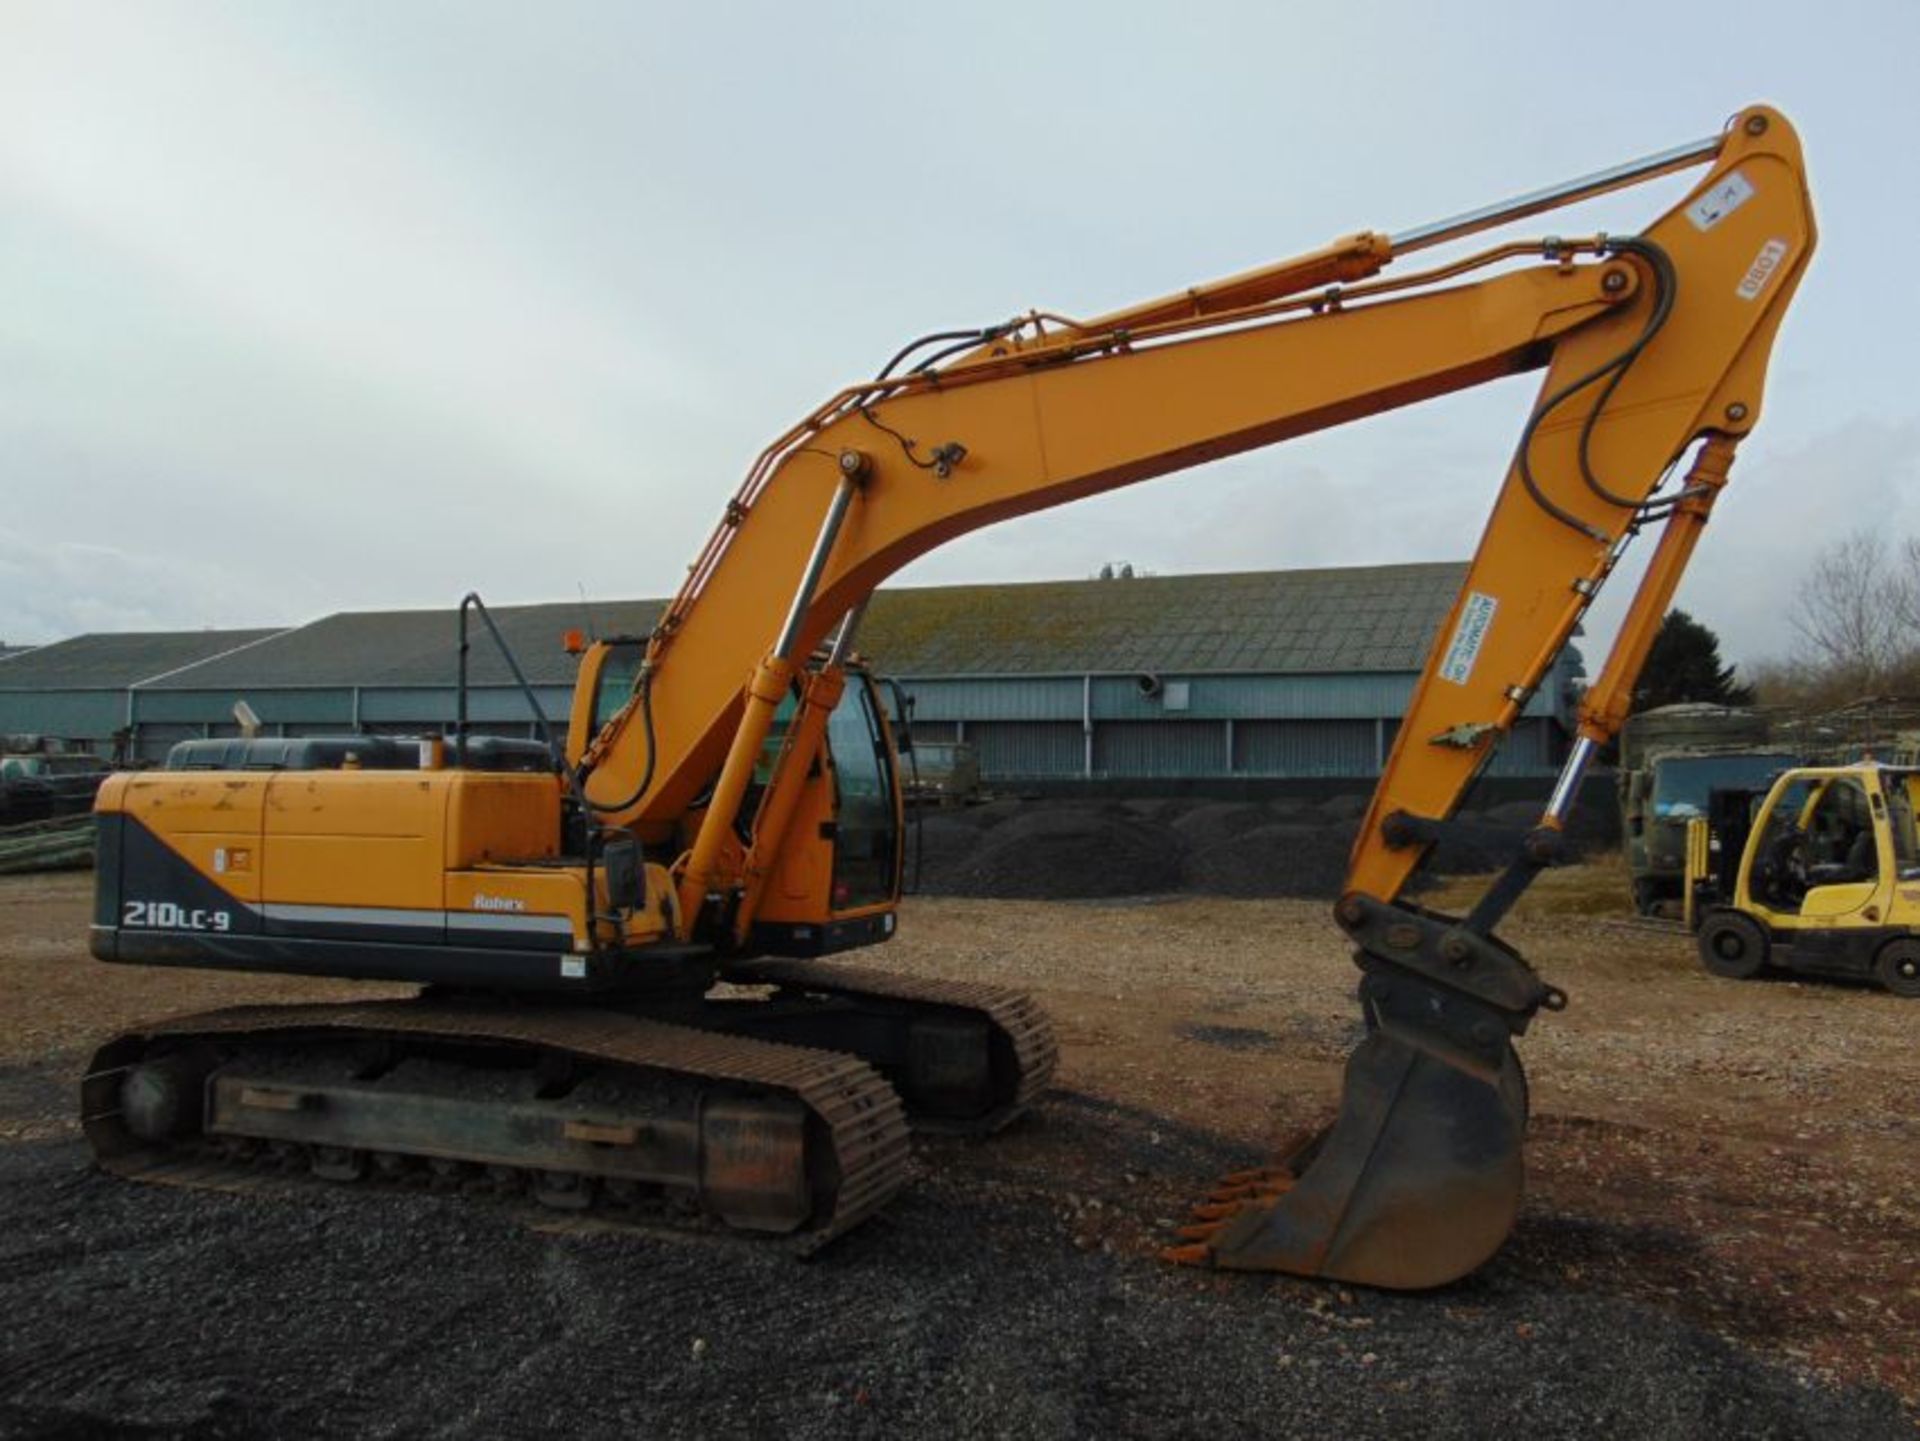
[{"x1": 0, "y1": 562, "x2": 1467, "y2": 691}]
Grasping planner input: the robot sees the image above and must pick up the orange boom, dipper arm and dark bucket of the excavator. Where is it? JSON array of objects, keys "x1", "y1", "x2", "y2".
[{"x1": 574, "y1": 107, "x2": 1814, "y2": 1287}]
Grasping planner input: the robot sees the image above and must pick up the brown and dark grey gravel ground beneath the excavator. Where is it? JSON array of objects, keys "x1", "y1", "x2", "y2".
[{"x1": 0, "y1": 877, "x2": 1920, "y2": 1437}]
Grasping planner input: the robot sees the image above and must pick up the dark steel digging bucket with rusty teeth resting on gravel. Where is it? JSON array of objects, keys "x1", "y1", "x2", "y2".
[{"x1": 1167, "y1": 1028, "x2": 1526, "y2": 1291}]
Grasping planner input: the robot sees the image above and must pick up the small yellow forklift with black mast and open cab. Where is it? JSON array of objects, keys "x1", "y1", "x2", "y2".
[{"x1": 1688, "y1": 760, "x2": 1920, "y2": 996}]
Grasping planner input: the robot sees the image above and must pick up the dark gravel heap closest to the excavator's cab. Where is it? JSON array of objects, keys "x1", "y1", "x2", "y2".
[{"x1": 927, "y1": 806, "x2": 1181, "y2": 900}]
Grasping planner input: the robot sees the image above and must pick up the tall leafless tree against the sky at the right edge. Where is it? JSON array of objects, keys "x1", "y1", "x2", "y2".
[{"x1": 1788, "y1": 530, "x2": 1920, "y2": 697}]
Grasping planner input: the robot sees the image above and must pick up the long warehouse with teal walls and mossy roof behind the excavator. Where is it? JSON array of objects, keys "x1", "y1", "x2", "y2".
[{"x1": 0, "y1": 562, "x2": 1580, "y2": 791}]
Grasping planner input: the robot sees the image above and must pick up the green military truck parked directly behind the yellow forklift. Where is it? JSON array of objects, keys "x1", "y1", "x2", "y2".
[{"x1": 1619, "y1": 702, "x2": 1805, "y2": 915}]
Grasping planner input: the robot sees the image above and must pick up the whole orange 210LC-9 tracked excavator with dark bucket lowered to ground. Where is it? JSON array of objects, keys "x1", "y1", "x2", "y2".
[{"x1": 83, "y1": 106, "x2": 1814, "y2": 1287}]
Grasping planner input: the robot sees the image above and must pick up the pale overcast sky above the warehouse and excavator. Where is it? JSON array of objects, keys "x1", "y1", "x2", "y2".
[{"x1": 0, "y1": 0, "x2": 1920, "y2": 660}]
